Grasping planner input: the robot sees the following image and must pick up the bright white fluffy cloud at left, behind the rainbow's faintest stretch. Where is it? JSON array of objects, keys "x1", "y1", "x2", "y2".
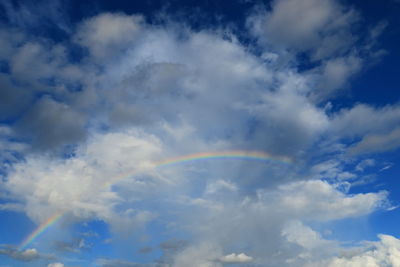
[{"x1": 3, "y1": 132, "x2": 160, "y2": 226}]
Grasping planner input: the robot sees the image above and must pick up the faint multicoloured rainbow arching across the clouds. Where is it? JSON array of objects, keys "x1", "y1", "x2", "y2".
[{"x1": 19, "y1": 150, "x2": 292, "y2": 250}]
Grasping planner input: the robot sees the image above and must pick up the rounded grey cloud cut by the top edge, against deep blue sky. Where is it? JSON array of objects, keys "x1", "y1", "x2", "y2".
[{"x1": 250, "y1": 0, "x2": 359, "y2": 59}]
